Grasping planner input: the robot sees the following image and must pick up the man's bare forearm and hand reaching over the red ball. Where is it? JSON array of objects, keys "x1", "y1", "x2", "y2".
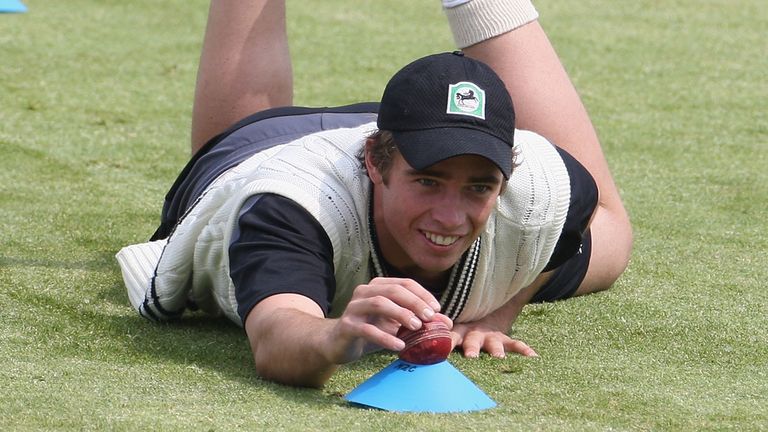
[{"x1": 245, "y1": 278, "x2": 453, "y2": 387}]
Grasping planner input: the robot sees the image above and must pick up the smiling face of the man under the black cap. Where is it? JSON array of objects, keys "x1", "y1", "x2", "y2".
[{"x1": 366, "y1": 140, "x2": 504, "y2": 283}]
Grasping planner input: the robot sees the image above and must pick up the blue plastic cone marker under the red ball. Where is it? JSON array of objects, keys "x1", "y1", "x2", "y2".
[{"x1": 344, "y1": 360, "x2": 496, "y2": 413}]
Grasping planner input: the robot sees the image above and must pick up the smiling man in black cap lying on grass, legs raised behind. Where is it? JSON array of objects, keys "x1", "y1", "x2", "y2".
[{"x1": 118, "y1": 0, "x2": 631, "y2": 386}]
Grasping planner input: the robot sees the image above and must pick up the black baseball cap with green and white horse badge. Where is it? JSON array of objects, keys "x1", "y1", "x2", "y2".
[{"x1": 377, "y1": 51, "x2": 515, "y2": 178}]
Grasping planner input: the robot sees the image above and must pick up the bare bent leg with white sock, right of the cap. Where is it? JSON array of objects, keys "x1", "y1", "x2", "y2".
[{"x1": 446, "y1": 0, "x2": 632, "y2": 295}]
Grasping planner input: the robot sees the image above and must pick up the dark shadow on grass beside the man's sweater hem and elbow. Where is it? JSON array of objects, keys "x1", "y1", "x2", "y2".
[{"x1": 0, "y1": 246, "x2": 343, "y2": 408}]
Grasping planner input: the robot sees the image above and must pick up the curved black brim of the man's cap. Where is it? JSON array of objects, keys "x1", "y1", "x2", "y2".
[{"x1": 392, "y1": 127, "x2": 513, "y2": 178}]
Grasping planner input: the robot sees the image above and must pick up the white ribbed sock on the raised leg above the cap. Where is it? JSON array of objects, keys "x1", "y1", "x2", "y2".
[{"x1": 442, "y1": 0, "x2": 539, "y2": 48}]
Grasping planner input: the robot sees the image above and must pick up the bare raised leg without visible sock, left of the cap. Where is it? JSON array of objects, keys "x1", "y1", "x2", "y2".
[{"x1": 192, "y1": 0, "x2": 293, "y2": 153}]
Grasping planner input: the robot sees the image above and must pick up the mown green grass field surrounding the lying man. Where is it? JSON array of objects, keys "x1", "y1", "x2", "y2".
[{"x1": 0, "y1": 0, "x2": 768, "y2": 431}]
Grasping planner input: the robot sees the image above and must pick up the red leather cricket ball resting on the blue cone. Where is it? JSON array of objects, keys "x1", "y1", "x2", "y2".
[{"x1": 397, "y1": 321, "x2": 452, "y2": 365}]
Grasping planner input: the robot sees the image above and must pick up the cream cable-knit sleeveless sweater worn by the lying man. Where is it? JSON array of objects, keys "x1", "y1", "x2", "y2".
[{"x1": 117, "y1": 123, "x2": 570, "y2": 325}]
